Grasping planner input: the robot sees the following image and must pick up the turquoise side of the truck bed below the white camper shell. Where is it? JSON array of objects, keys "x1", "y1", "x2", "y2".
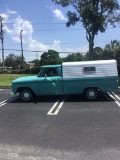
[{"x1": 63, "y1": 77, "x2": 118, "y2": 94}]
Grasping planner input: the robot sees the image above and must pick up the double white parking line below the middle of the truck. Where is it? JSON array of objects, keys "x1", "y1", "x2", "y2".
[{"x1": 47, "y1": 96, "x2": 66, "y2": 115}]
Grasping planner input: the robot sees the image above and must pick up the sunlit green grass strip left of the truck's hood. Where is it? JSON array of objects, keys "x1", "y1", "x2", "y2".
[{"x1": 0, "y1": 74, "x2": 34, "y2": 88}]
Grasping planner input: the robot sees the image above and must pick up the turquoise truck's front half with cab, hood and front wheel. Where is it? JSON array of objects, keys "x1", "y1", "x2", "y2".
[{"x1": 12, "y1": 65, "x2": 63, "y2": 101}]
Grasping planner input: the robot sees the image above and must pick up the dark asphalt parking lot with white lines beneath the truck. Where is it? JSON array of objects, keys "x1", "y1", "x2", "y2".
[{"x1": 0, "y1": 89, "x2": 120, "y2": 160}]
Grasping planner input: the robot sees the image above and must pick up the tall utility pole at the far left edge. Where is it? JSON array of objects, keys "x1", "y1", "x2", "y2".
[{"x1": 0, "y1": 16, "x2": 5, "y2": 70}]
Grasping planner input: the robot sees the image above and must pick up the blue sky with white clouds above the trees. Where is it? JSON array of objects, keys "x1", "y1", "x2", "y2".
[{"x1": 0, "y1": 0, "x2": 120, "y2": 62}]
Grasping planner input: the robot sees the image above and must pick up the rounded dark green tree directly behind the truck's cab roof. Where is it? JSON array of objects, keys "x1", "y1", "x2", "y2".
[{"x1": 40, "y1": 50, "x2": 62, "y2": 65}]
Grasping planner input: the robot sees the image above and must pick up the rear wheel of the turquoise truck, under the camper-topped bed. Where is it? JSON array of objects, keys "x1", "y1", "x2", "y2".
[{"x1": 84, "y1": 88, "x2": 98, "y2": 100}]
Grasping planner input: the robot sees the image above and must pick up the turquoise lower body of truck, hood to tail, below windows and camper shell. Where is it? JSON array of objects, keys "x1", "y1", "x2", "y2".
[{"x1": 12, "y1": 76, "x2": 118, "y2": 95}]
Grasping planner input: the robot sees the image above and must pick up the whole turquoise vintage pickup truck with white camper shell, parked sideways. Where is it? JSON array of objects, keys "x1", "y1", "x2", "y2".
[{"x1": 12, "y1": 60, "x2": 118, "y2": 102}]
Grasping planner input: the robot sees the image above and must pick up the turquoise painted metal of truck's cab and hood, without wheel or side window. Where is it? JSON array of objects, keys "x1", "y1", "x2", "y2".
[{"x1": 12, "y1": 65, "x2": 63, "y2": 95}]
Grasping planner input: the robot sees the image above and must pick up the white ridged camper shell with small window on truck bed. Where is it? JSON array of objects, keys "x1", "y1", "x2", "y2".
[{"x1": 62, "y1": 60, "x2": 118, "y2": 79}]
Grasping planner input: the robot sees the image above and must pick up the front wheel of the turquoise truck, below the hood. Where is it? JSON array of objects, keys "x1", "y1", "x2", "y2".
[{"x1": 20, "y1": 89, "x2": 34, "y2": 102}]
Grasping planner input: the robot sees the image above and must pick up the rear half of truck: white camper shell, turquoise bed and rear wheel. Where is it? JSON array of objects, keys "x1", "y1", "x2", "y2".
[{"x1": 62, "y1": 60, "x2": 118, "y2": 99}]
